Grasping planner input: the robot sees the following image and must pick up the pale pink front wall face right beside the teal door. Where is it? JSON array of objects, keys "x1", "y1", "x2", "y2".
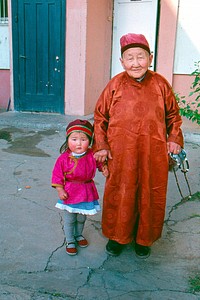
[{"x1": 65, "y1": 0, "x2": 87, "y2": 115}]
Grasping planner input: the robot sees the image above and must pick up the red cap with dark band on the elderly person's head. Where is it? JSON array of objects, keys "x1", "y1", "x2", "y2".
[{"x1": 120, "y1": 33, "x2": 151, "y2": 55}]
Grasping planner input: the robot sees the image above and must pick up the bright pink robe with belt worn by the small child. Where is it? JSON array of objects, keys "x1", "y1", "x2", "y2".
[{"x1": 51, "y1": 149, "x2": 102, "y2": 213}]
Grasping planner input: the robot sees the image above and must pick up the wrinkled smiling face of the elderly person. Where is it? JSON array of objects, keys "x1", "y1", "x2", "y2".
[{"x1": 120, "y1": 47, "x2": 153, "y2": 79}]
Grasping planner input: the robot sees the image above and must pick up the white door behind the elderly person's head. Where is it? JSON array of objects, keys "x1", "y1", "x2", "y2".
[{"x1": 111, "y1": 0, "x2": 159, "y2": 77}]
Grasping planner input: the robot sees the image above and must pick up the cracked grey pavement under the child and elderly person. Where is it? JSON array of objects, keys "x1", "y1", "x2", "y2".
[{"x1": 0, "y1": 112, "x2": 200, "y2": 300}]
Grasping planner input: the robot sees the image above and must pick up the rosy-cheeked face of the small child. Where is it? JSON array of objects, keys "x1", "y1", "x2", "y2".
[{"x1": 68, "y1": 132, "x2": 90, "y2": 154}]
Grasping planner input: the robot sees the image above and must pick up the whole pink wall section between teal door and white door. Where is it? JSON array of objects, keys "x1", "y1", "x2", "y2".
[{"x1": 65, "y1": 0, "x2": 113, "y2": 115}]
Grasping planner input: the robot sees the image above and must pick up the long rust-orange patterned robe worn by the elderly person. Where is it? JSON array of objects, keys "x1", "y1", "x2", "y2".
[{"x1": 94, "y1": 71, "x2": 183, "y2": 246}]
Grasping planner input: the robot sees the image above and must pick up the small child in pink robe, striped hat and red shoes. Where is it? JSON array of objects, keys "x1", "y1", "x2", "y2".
[{"x1": 52, "y1": 119, "x2": 108, "y2": 255}]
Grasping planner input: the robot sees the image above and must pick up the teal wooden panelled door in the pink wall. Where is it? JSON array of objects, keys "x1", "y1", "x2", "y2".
[{"x1": 11, "y1": 0, "x2": 66, "y2": 113}]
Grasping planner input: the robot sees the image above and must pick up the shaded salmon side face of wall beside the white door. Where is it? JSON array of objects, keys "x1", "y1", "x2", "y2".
[{"x1": 85, "y1": 0, "x2": 113, "y2": 114}]
